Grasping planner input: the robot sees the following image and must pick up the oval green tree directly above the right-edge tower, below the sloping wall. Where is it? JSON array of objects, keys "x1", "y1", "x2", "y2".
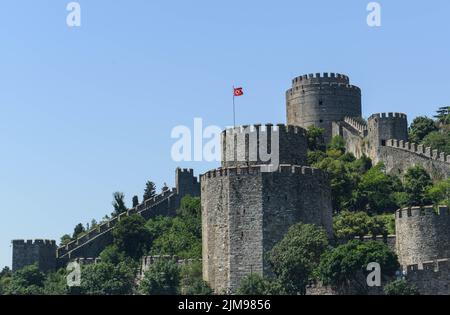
[{"x1": 404, "y1": 165, "x2": 433, "y2": 206}]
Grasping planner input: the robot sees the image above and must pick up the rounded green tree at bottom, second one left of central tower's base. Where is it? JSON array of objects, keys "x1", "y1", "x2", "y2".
[{"x1": 139, "y1": 259, "x2": 180, "y2": 295}]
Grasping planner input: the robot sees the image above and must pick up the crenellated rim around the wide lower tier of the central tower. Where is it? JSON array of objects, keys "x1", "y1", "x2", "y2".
[{"x1": 201, "y1": 165, "x2": 327, "y2": 181}]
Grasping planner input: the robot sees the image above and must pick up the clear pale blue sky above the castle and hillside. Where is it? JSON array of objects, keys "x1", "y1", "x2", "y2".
[{"x1": 0, "y1": 0, "x2": 450, "y2": 266}]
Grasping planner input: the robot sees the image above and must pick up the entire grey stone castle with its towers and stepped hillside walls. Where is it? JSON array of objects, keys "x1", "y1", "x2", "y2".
[{"x1": 13, "y1": 73, "x2": 450, "y2": 294}]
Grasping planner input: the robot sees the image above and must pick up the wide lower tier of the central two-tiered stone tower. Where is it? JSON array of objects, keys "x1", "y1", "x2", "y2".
[{"x1": 201, "y1": 165, "x2": 332, "y2": 293}]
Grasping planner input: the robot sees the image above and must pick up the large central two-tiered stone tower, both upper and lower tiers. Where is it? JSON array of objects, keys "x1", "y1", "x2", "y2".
[{"x1": 201, "y1": 125, "x2": 332, "y2": 293}]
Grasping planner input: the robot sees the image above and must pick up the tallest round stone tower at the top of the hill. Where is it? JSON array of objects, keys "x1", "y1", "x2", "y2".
[{"x1": 286, "y1": 73, "x2": 361, "y2": 142}]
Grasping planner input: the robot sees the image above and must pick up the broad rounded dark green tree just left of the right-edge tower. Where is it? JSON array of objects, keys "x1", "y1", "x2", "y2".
[{"x1": 317, "y1": 241, "x2": 400, "y2": 294}]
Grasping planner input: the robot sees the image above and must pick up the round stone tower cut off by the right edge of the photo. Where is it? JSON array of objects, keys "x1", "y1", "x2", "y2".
[{"x1": 395, "y1": 207, "x2": 450, "y2": 267}]
